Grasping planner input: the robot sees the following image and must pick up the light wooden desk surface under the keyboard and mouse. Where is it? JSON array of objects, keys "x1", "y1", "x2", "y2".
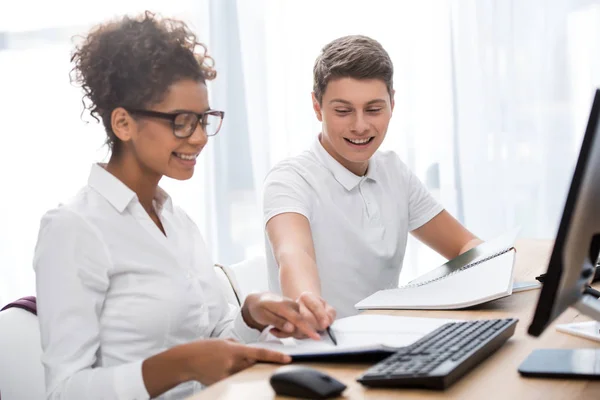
[{"x1": 189, "y1": 240, "x2": 600, "y2": 400}]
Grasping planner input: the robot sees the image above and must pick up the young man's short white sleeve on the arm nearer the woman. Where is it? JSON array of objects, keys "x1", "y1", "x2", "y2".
[{"x1": 263, "y1": 164, "x2": 312, "y2": 225}]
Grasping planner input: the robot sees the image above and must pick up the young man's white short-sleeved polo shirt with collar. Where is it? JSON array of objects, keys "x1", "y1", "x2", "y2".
[{"x1": 263, "y1": 140, "x2": 443, "y2": 317}]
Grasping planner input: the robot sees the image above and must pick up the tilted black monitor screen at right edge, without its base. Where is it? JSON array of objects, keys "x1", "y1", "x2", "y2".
[{"x1": 528, "y1": 90, "x2": 600, "y2": 336}]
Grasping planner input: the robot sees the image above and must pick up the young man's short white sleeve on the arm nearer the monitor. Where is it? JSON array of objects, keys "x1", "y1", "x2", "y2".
[{"x1": 407, "y1": 164, "x2": 444, "y2": 231}]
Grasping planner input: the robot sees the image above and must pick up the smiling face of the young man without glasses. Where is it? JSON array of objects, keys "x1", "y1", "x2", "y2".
[{"x1": 313, "y1": 78, "x2": 394, "y2": 176}]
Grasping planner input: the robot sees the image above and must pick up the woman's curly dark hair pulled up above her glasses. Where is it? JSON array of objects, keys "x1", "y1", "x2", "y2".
[{"x1": 70, "y1": 11, "x2": 217, "y2": 153}]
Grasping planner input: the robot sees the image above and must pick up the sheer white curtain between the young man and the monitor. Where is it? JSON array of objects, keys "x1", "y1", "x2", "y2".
[{"x1": 452, "y1": 0, "x2": 599, "y2": 238}]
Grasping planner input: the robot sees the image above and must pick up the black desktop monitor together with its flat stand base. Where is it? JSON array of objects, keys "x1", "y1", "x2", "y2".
[{"x1": 519, "y1": 90, "x2": 600, "y2": 380}]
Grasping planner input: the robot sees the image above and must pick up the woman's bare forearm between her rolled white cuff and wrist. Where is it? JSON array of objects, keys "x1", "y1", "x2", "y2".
[{"x1": 142, "y1": 346, "x2": 191, "y2": 398}]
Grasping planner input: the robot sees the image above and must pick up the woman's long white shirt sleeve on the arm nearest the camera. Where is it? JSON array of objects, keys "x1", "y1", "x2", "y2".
[{"x1": 33, "y1": 208, "x2": 149, "y2": 400}]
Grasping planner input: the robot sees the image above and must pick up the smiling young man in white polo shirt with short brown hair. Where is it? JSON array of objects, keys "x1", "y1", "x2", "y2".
[{"x1": 264, "y1": 36, "x2": 480, "y2": 329}]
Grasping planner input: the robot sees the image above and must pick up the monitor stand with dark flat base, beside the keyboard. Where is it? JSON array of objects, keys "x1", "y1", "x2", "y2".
[{"x1": 519, "y1": 294, "x2": 600, "y2": 380}]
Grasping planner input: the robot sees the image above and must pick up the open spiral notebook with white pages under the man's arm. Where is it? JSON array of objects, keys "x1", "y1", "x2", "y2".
[{"x1": 355, "y1": 229, "x2": 519, "y2": 310}]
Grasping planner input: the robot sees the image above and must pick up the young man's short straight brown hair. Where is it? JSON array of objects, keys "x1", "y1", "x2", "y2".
[{"x1": 313, "y1": 35, "x2": 394, "y2": 103}]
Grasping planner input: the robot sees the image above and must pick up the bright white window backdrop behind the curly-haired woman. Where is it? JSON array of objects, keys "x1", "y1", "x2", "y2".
[{"x1": 0, "y1": 0, "x2": 210, "y2": 306}]
